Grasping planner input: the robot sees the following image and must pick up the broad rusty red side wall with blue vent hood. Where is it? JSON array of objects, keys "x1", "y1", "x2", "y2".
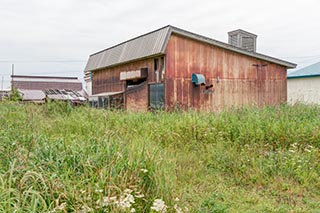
[{"x1": 165, "y1": 34, "x2": 287, "y2": 110}]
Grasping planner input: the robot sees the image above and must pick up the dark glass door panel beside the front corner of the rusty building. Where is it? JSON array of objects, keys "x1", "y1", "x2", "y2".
[{"x1": 149, "y1": 84, "x2": 164, "y2": 109}]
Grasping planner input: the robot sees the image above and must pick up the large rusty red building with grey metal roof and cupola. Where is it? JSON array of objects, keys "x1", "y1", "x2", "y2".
[{"x1": 85, "y1": 26, "x2": 296, "y2": 111}]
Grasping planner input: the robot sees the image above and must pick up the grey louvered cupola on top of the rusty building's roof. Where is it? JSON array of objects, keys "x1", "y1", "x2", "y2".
[{"x1": 228, "y1": 29, "x2": 257, "y2": 52}]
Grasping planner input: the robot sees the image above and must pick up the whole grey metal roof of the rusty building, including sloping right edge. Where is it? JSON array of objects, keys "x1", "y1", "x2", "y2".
[{"x1": 85, "y1": 25, "x2": 296, "y2": 71}]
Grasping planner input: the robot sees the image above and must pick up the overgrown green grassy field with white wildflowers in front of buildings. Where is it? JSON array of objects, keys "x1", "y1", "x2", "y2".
[{"x1": 0, "y1": 102, "x2": 320, "y2": 212}]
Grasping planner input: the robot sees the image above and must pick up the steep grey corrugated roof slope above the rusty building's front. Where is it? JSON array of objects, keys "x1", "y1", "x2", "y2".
[{"x1": 85, "y1": 26, "x2": 170, "y2": 71}]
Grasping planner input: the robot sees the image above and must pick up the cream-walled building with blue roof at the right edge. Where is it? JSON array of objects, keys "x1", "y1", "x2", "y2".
[{"x1": 287, "y1": 62, "x2": 320, "y2": 104}]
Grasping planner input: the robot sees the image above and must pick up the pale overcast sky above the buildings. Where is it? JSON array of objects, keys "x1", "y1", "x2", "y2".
[{"x1": 0, "y1": 0, "x2": 320, "y2": 89}]
